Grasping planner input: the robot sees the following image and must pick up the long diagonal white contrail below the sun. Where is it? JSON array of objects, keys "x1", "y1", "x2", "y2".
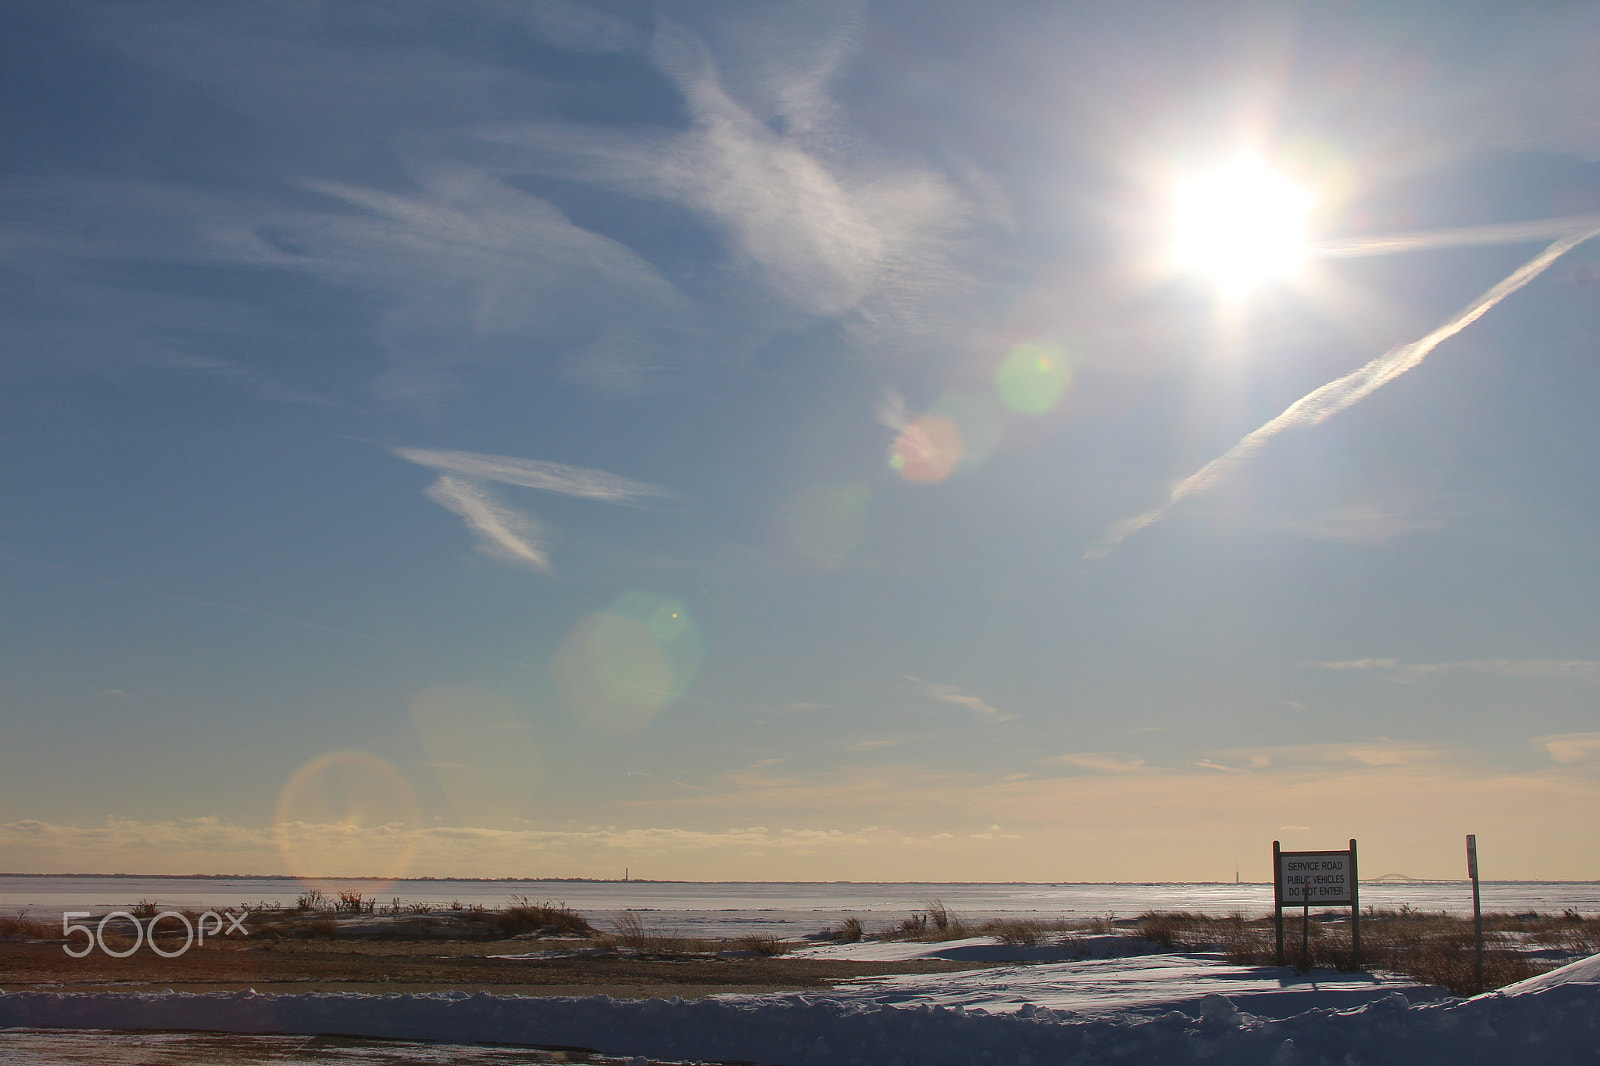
[{"x1": 1083, "y1": 218, "x2": 1600, "y2": 559}]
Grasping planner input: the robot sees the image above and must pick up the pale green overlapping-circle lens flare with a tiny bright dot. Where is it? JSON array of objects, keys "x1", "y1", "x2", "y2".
[{"x1": 555, "y1": 592, "x2": 706, "y2": 733}]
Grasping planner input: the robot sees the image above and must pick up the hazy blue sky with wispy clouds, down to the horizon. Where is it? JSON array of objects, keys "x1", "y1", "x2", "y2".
[{"x1": 0, "y1": 0, "x2": 1600, "y2": 882}]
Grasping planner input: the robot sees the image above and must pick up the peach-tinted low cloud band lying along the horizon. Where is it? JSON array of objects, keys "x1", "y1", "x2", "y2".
[{"x1": 12, "y1": 735, "x2": 1600, "y2": 880}]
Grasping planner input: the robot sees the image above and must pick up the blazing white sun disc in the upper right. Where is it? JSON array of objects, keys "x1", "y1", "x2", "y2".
[{"x1": 1171, "y1": 155, "x2": 1310, "y2": 298}]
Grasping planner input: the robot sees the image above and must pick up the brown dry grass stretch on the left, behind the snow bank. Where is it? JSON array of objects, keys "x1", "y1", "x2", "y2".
[{"x1": 0, "y1": 896, "x2": 982, "y2": 999}]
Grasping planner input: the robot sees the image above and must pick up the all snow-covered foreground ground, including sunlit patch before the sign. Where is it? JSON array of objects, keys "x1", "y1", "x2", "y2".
[{"x1": 9, "y1": 940, "x2": 1600, "y2": 1066}]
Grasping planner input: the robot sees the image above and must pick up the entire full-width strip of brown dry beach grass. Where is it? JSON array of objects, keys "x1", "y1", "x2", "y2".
[{"x1": 0, "y1": 896, "x2": 1600, "y2": 997}]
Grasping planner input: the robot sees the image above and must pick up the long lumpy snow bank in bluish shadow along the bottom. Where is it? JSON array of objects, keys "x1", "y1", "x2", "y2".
[{"x1": 0, "y1": 960, "x2": 1600, "y2": 1066}]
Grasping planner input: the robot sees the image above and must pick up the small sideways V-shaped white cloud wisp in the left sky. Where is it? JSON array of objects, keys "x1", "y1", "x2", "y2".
[{"x1": 400, "y1": 448, "x2": 672, "y2": 573}]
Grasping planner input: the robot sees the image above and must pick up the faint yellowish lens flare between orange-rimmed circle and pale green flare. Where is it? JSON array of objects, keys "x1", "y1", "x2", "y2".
[{"x1": 411, "y1": 687, "x2": 541, "y2": 826}]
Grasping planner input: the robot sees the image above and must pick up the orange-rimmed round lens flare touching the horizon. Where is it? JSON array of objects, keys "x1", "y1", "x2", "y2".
[{"x1": 272, "y1": 751, "x2": 421, "y2": 893}]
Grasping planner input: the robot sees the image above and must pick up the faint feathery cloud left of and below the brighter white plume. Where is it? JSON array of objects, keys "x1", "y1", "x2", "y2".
[{"x1": 289, "y1": 168, "x2": 688, "y2": 405}]
